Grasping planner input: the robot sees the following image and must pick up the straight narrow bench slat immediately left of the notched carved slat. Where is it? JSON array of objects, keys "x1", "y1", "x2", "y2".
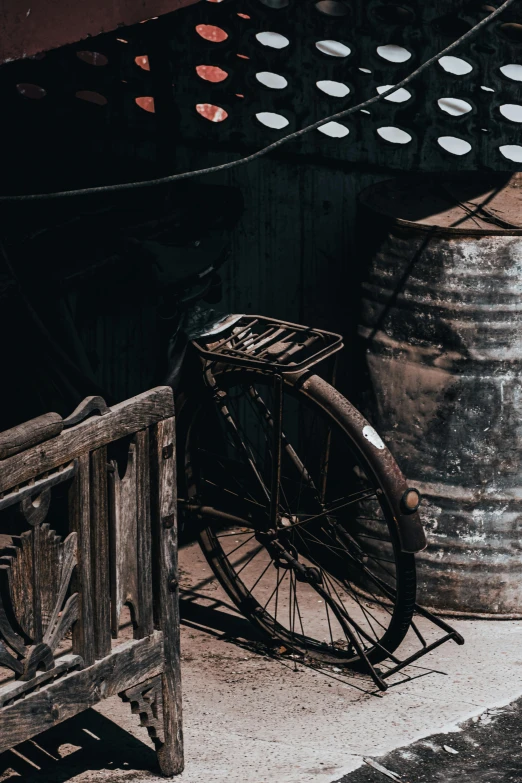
[{"x1": 90, "y1": 446, "x2": 111, "y2": 658}]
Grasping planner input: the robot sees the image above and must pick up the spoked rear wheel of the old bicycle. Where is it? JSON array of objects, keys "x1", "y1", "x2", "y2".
[{"x1": 180, "y1": 369, "x2": 416, "y2": 666}]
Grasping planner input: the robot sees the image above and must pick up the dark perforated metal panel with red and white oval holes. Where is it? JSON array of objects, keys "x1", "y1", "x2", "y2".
[{"x1": 0, "y1": 0, "x2": 522, "y2": 182}]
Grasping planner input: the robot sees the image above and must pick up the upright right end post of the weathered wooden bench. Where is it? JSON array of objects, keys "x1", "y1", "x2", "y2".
[{"x1": 151, "y1": 418, "x2": 184, "y2": 775}]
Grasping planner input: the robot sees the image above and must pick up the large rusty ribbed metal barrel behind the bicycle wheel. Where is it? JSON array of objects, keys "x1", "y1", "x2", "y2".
[{"x1": 359, "y1": 174, "x2": 522, "y2": 618}]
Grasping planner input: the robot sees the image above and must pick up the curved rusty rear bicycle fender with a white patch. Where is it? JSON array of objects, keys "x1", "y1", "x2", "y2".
[{"x1": 290, "y1": 373, "x2": 427, "y2": 554}]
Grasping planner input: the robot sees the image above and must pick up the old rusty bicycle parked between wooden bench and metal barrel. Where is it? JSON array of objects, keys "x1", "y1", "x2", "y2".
[{"x1": 7, "y1": 179, "x2": 426, "y2": 690}]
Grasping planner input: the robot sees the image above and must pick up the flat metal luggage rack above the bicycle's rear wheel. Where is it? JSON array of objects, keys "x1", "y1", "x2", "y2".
[{"x1": 192, "y1": 315, "x2": 343, "y2": 373}]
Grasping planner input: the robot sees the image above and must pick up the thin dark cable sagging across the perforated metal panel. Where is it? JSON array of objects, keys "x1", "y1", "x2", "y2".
[{"x1": 0, "y1": 0, "x2": 518, "y2": 203}]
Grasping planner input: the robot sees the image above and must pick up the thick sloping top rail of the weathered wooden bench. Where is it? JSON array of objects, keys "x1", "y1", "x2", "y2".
[{"x1": 0, "y1": 386, "x2": 174, "y2": 492}]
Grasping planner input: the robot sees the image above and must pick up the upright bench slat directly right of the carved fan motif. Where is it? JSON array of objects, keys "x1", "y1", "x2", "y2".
[{"x1": 69, "y1": 453, "x2": 95, "y2": 666}]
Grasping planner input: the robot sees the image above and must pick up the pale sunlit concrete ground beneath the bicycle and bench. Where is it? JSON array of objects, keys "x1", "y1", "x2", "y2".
[{"x1": 0, "y1": 545, "x2": 522, "y2": 783}]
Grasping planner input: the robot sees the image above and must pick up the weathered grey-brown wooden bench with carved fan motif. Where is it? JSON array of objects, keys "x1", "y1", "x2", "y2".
[{"x1": 0, "y1": 387, "x2": 183, "y2": 776}]
